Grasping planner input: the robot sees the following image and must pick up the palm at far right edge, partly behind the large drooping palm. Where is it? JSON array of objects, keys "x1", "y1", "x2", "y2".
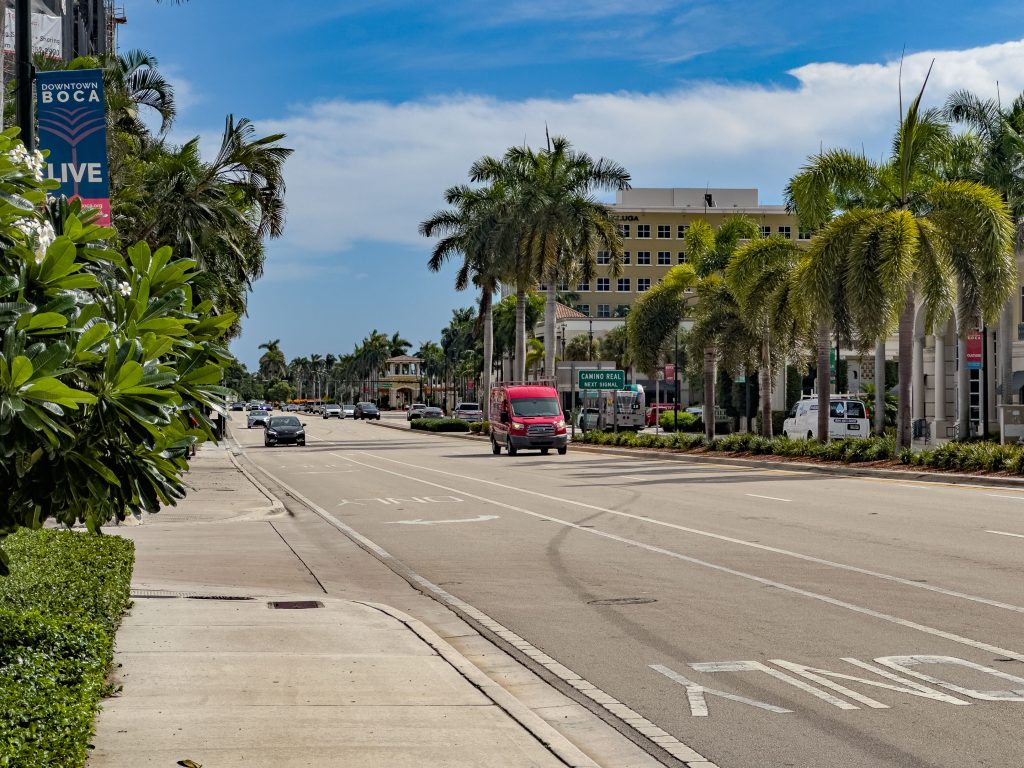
[{"x1": 943, "y1": 90, "x2": 1024, "y2": 428}]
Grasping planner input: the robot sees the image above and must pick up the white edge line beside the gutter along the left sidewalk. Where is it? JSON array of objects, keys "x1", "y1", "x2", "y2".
[{"x1": 236, "y1": 448, "x2": 714, "y2": 766}]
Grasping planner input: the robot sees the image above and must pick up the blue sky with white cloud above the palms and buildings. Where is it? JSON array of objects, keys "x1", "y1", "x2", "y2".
[{"x1": 119, "y1": 0, "x2": 1024, "y2": 368}]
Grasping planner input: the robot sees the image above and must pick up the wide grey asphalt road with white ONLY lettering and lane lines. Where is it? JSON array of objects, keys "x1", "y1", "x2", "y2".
[{"x1": 236, "y1": 417, "x2": 1024, "y2": 768}]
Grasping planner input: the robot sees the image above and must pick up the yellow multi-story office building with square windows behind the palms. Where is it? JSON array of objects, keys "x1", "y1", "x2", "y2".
[{"x1": 559, "y1": 187, "x2": 798, "y2": 317}]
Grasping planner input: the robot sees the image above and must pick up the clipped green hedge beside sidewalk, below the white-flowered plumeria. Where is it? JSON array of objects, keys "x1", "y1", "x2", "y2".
[{"x1": 0, "y1": 529, "x2": 134, "y2": 768}]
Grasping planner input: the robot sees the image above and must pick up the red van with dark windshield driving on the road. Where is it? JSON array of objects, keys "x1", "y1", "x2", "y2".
[{"x1": 487, "y1": 384, "x2": 568, "y2": 456}]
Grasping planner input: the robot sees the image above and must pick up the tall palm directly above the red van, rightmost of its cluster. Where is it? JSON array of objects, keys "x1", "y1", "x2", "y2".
[{"x1": 505, "y1": 136, "x2": 630, "y2": 378}]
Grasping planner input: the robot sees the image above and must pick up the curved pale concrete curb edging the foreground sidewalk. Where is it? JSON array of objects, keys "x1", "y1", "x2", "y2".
[{"x1": 353, "y1": 600, "x2": 599, "y2": 768}]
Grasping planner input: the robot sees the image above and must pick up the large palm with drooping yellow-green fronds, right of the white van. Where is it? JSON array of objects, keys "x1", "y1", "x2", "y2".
[{"x1": 787, "y1": 78, "x2": 1015, "y2": 447}]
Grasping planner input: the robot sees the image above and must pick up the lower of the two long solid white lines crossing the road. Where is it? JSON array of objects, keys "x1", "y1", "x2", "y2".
[{"x1": 333, "y1": 457, "x2": 1024, "y2": 662}]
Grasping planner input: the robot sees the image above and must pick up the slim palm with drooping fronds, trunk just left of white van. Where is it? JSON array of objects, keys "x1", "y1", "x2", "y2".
[{"x1": 725, "y1": 236, "x2": 806, "y2": 437}]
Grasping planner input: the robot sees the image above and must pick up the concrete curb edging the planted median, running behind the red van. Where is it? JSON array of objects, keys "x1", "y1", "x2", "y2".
[{"x1": 378, "y1": 424, "x2": 1024, "y2": 488}]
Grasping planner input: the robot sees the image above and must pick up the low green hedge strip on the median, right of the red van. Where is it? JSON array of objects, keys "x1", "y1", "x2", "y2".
[{"x1": 575, "y1": 432, "x2": 1024, "y2": 475}]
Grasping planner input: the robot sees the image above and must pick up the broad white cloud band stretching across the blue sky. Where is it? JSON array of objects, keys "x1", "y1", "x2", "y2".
[{"x1": 259, "y1": 41, "x2": 1024, "y2": 262}]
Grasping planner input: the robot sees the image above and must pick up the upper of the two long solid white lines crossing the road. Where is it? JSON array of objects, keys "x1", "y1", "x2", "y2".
[{"x1": 353, "y1": 452, "x2": 1024, "y2": 613}]
